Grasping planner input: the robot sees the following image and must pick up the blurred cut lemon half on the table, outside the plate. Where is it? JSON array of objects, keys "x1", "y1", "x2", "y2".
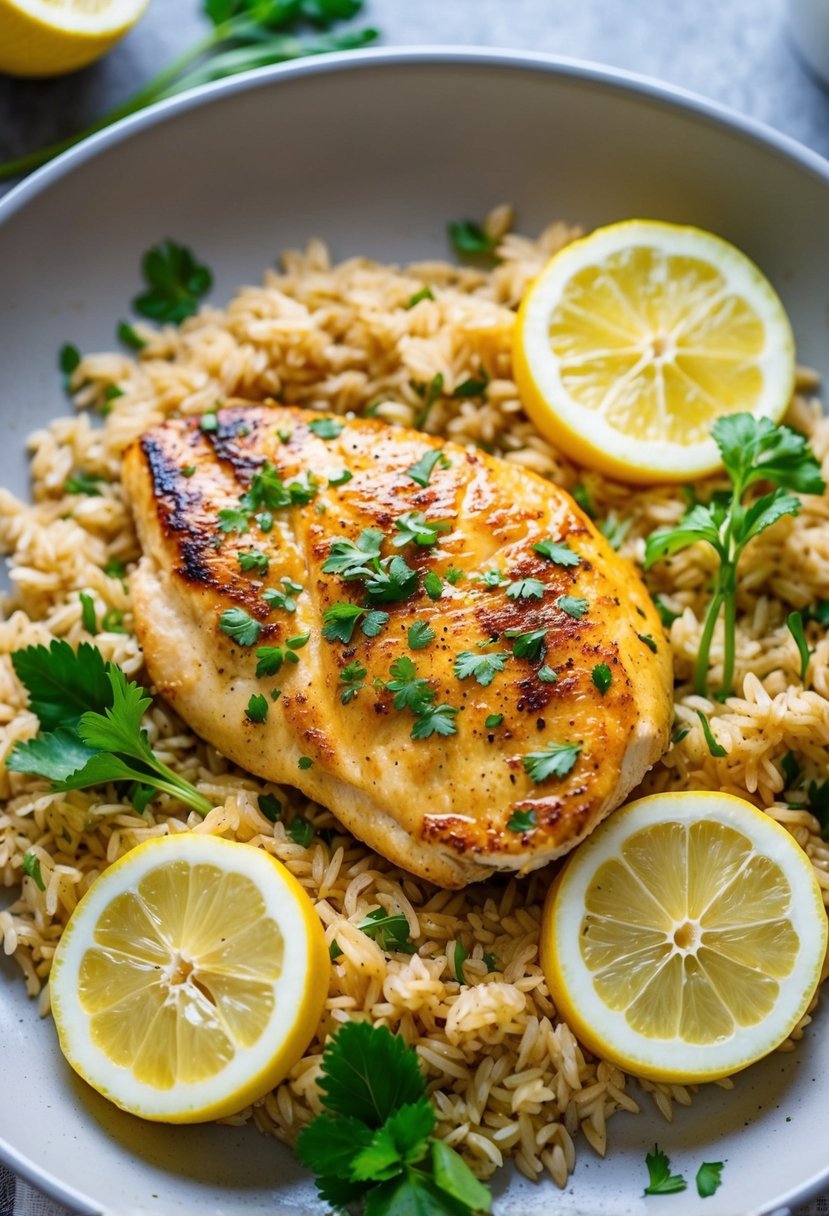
[{"x1": 0, "y1": 0, "x2": 148, "y2": 77}]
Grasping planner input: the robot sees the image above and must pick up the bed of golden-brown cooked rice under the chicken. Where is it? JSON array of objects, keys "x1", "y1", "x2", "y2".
[{"x1": 0, "y1": 207, "x2": 829, "y2": 1187}]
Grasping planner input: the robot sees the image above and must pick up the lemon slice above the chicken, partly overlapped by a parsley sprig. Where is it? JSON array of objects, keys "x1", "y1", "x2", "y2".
[{"x1": 514, "y1": 220, "x2": 795, "y2": 483}]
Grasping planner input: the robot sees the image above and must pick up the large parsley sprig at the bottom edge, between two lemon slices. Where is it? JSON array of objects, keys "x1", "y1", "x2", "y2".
[{"x1": 297, "y1": 1021, "x2": 492, "y2": 1216}]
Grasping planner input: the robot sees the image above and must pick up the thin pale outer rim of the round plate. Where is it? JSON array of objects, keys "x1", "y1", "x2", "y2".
[{"x1": 0, "y1": 44, "x2": 829, "y2": 1216}]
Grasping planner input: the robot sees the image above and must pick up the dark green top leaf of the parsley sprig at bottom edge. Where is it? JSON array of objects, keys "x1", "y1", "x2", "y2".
[{"x1": 318, "y1": 1021, "x2": 425, "y2": 1128}]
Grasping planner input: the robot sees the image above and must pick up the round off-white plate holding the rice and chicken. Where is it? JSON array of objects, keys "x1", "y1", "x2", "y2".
[{"x1": 0, "y1": 50, "x2": 829, "y2": 1216}]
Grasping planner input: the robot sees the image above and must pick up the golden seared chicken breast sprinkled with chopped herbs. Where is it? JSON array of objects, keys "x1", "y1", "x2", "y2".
[{"x1": 124, "y1": 404, "x2": 671, "y2": 886}]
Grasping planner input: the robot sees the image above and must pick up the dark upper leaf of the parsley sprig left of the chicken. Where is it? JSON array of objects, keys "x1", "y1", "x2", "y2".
[{"x1": 11, "y1": 640, "x2": 112, "y2": 731}]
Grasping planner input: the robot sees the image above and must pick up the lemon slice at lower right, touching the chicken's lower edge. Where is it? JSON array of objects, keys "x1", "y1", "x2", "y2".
[{"x1": 541, "y1": 790, "x2": 827, "y2": 1082}]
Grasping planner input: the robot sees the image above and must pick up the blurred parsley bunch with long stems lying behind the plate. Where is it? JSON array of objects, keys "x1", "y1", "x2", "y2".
[{"x1": 0, "y1": 0, "x2": 377, "y2": 181}]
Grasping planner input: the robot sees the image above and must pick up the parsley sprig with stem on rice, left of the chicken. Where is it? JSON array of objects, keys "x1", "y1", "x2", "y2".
[{"x1": 6, "y1": 641, "x2": 213, "y2": 815}]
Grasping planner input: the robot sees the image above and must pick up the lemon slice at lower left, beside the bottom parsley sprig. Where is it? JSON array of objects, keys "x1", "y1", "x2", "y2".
[{"x1": 50, "y1": 832, "x2": 329, "y2": 1124}]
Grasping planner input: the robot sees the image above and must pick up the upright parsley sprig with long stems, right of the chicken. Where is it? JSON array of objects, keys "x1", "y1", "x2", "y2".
[{"x1": 644, "y1": 413, "x2": 825, "y2": 697}]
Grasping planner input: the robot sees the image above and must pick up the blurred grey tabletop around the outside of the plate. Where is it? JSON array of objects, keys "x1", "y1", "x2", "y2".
[{"x1": 0, "y1": 0, "x2": 829, "y2": 1216}]
